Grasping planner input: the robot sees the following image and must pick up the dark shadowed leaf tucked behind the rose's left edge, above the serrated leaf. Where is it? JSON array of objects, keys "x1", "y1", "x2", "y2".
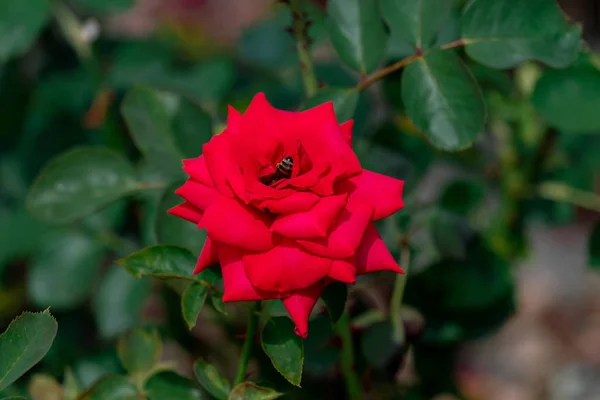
[{"x1": 156, "y1": 183, "x2": 206, "y2": 255}]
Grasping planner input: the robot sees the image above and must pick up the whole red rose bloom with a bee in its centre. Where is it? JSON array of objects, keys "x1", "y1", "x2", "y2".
[{"x1": 169, "y1": 93, "x2": 404, "y2": 337}]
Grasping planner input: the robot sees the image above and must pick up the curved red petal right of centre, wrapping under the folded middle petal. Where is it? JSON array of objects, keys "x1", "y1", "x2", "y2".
[{"x1": 296, "y1": 199, "x2": 373, "y2": 259}]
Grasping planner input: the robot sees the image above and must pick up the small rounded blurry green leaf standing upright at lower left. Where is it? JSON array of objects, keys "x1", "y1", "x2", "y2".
[{"x1": 117, "y1": 329, "x2": 162, "y2": 374}]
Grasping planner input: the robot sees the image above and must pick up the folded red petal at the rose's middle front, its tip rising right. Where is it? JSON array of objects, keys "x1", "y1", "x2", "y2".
[{"x1": 271, "y1": 195, "x2": 346, "y2": 239}]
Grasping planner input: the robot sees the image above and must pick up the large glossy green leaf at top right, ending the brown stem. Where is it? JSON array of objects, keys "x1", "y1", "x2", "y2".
[{"x1": 462, "y1": 0, "x2": 581, "y2": 68}]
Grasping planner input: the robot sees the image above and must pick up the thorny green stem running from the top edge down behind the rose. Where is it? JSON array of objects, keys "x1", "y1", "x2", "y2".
[{"x1": 287, "y1": 0, "x2": 318, "y2": 97}]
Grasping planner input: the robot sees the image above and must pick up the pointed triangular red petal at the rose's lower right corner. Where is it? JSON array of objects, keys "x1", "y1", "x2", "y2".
[{"x1": 356, "y1": 223, "x2": 404, "y2": 275}]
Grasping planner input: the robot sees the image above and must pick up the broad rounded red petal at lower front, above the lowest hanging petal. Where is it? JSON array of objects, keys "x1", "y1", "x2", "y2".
[{"x1": 244, "y1": 239, "x2": 331, "y2": 292}]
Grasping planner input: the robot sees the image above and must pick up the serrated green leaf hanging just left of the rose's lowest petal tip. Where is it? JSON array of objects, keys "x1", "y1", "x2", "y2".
[{"x1": 261, "y1": 317, "x2": 304, "y2": 386}]
